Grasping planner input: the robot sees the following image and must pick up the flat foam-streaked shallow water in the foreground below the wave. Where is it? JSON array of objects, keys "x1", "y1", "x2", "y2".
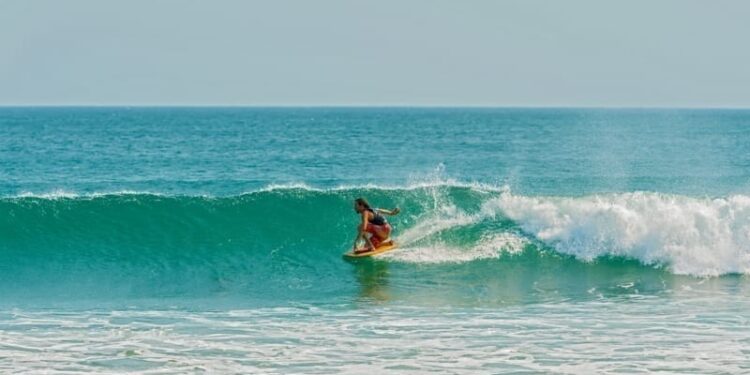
[{"x1": 0, "y1": 306, "x2": 750, "y2": 374}]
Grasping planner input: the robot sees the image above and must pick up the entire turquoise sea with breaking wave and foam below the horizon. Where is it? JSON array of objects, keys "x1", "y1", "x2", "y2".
[{"x1": 0, "y1": 108, "x2": 750, "y2": 374}]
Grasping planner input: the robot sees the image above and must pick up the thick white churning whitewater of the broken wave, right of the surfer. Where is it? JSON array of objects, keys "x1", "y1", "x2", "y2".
[{"x1": 483, "y1": 192, "x2": 750, "y2": 276}]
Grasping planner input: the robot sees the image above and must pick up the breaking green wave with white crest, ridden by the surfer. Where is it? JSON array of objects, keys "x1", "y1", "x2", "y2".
[{"x1": 0, "y1": 184, "x2": 750, "y2": 301}]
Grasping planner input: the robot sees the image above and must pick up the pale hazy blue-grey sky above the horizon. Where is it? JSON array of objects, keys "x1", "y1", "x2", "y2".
[{"x1": 0, "y1": 0, "x2": 750, "y2": 107}]
